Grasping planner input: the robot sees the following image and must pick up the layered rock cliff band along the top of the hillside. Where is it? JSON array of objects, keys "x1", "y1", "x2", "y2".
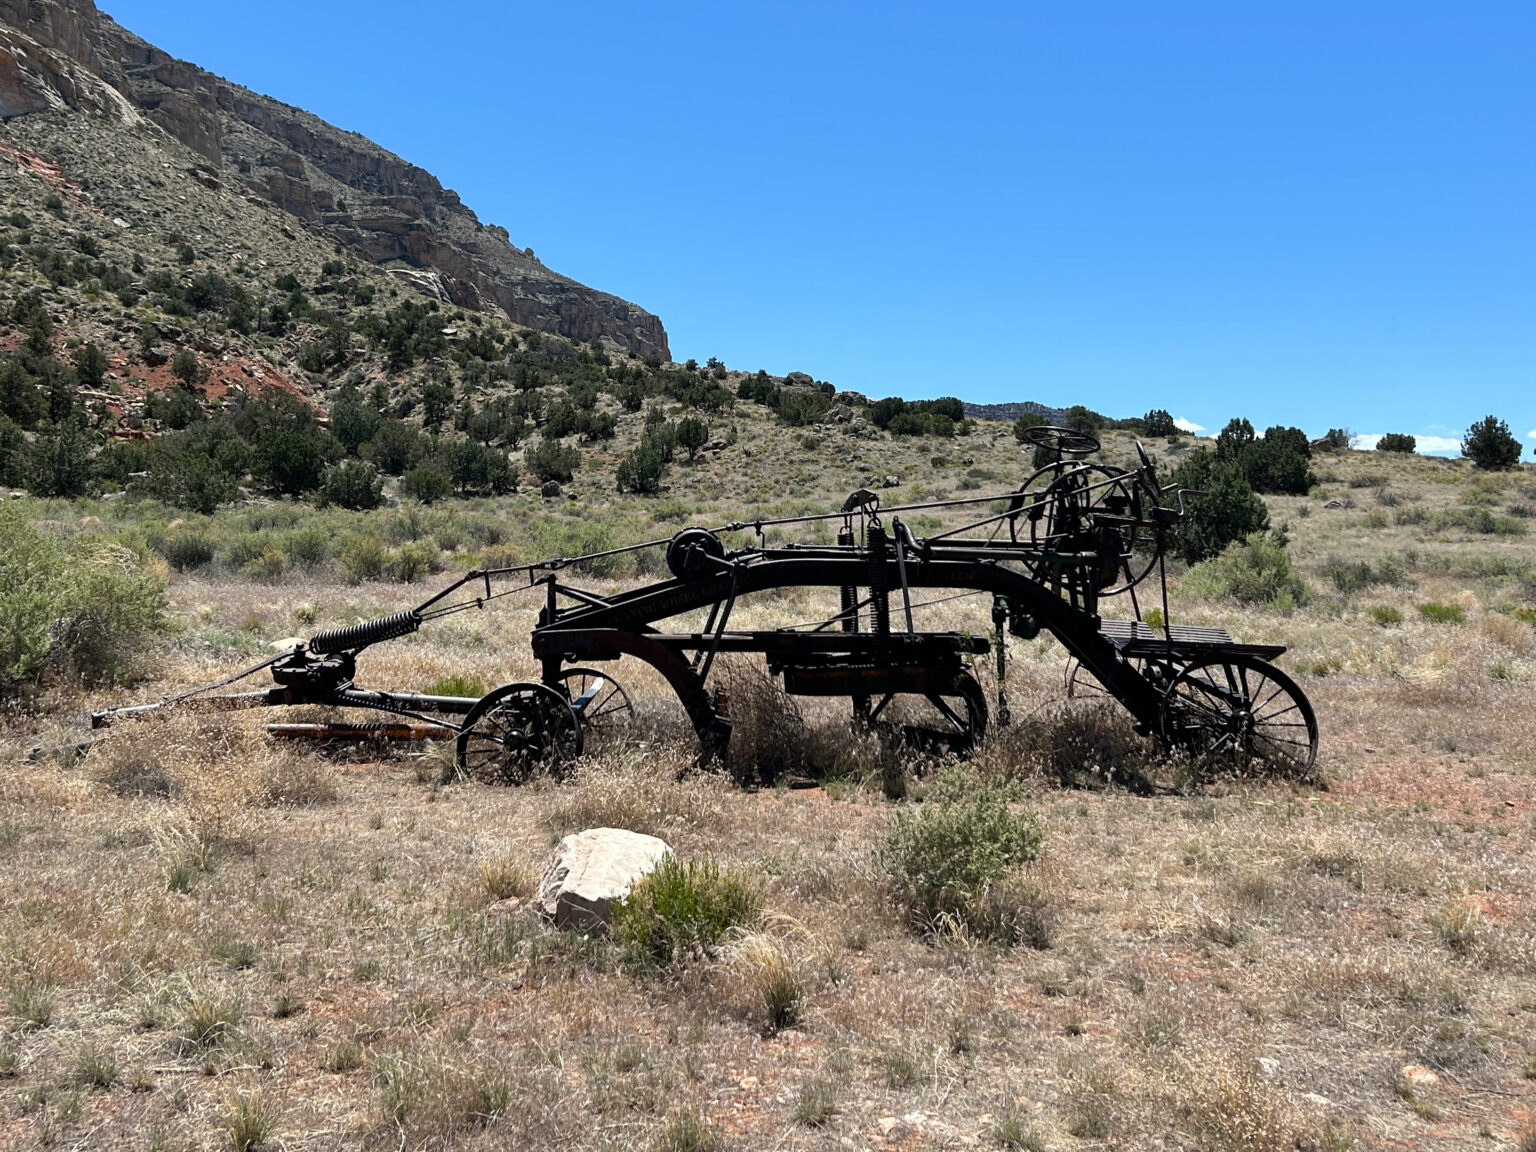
[{"x1": 0, "y1": 0, "x2": 670, "y2": 359}]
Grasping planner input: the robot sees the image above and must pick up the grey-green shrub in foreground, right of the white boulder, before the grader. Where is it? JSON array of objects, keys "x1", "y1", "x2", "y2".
[{"x1": 877, "y1": 768, "x2": 1044, "y2": 931}]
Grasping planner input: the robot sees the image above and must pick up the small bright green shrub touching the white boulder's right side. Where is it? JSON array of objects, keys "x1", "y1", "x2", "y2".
[{"x1": 613, "y1": 852, "x2": 762, "y2": 966}]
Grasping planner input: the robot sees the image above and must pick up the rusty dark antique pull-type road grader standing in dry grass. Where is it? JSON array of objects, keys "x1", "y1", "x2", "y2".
[{"x1": 92, "y1": 425, "x2": 1318, "y2": 782}]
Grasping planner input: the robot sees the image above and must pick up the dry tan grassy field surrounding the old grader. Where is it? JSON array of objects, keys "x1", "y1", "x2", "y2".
[{"x1": 0, "y1": 427, "x2": 1536, "y2": 1152}]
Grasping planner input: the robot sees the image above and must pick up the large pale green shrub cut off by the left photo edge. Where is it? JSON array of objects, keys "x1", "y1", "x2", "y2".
[{"x1": 0, "y1": 505, "x2": 169, "y2": 696}]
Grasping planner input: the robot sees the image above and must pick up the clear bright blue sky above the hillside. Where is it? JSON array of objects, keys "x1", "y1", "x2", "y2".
[{"x1": 104, "y1": 0, "x2": 1536, "y2": 444}]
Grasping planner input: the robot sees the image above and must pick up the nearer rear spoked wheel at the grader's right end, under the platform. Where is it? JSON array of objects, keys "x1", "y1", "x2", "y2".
[{"x1": 1163, "y1": 656, "x2": 1318, "y2": 774}]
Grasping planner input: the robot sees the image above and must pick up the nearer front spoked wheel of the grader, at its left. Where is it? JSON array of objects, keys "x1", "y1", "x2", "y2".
[{"x1": 458, "y1": 684, "x2": 582, "y2": 783}]
